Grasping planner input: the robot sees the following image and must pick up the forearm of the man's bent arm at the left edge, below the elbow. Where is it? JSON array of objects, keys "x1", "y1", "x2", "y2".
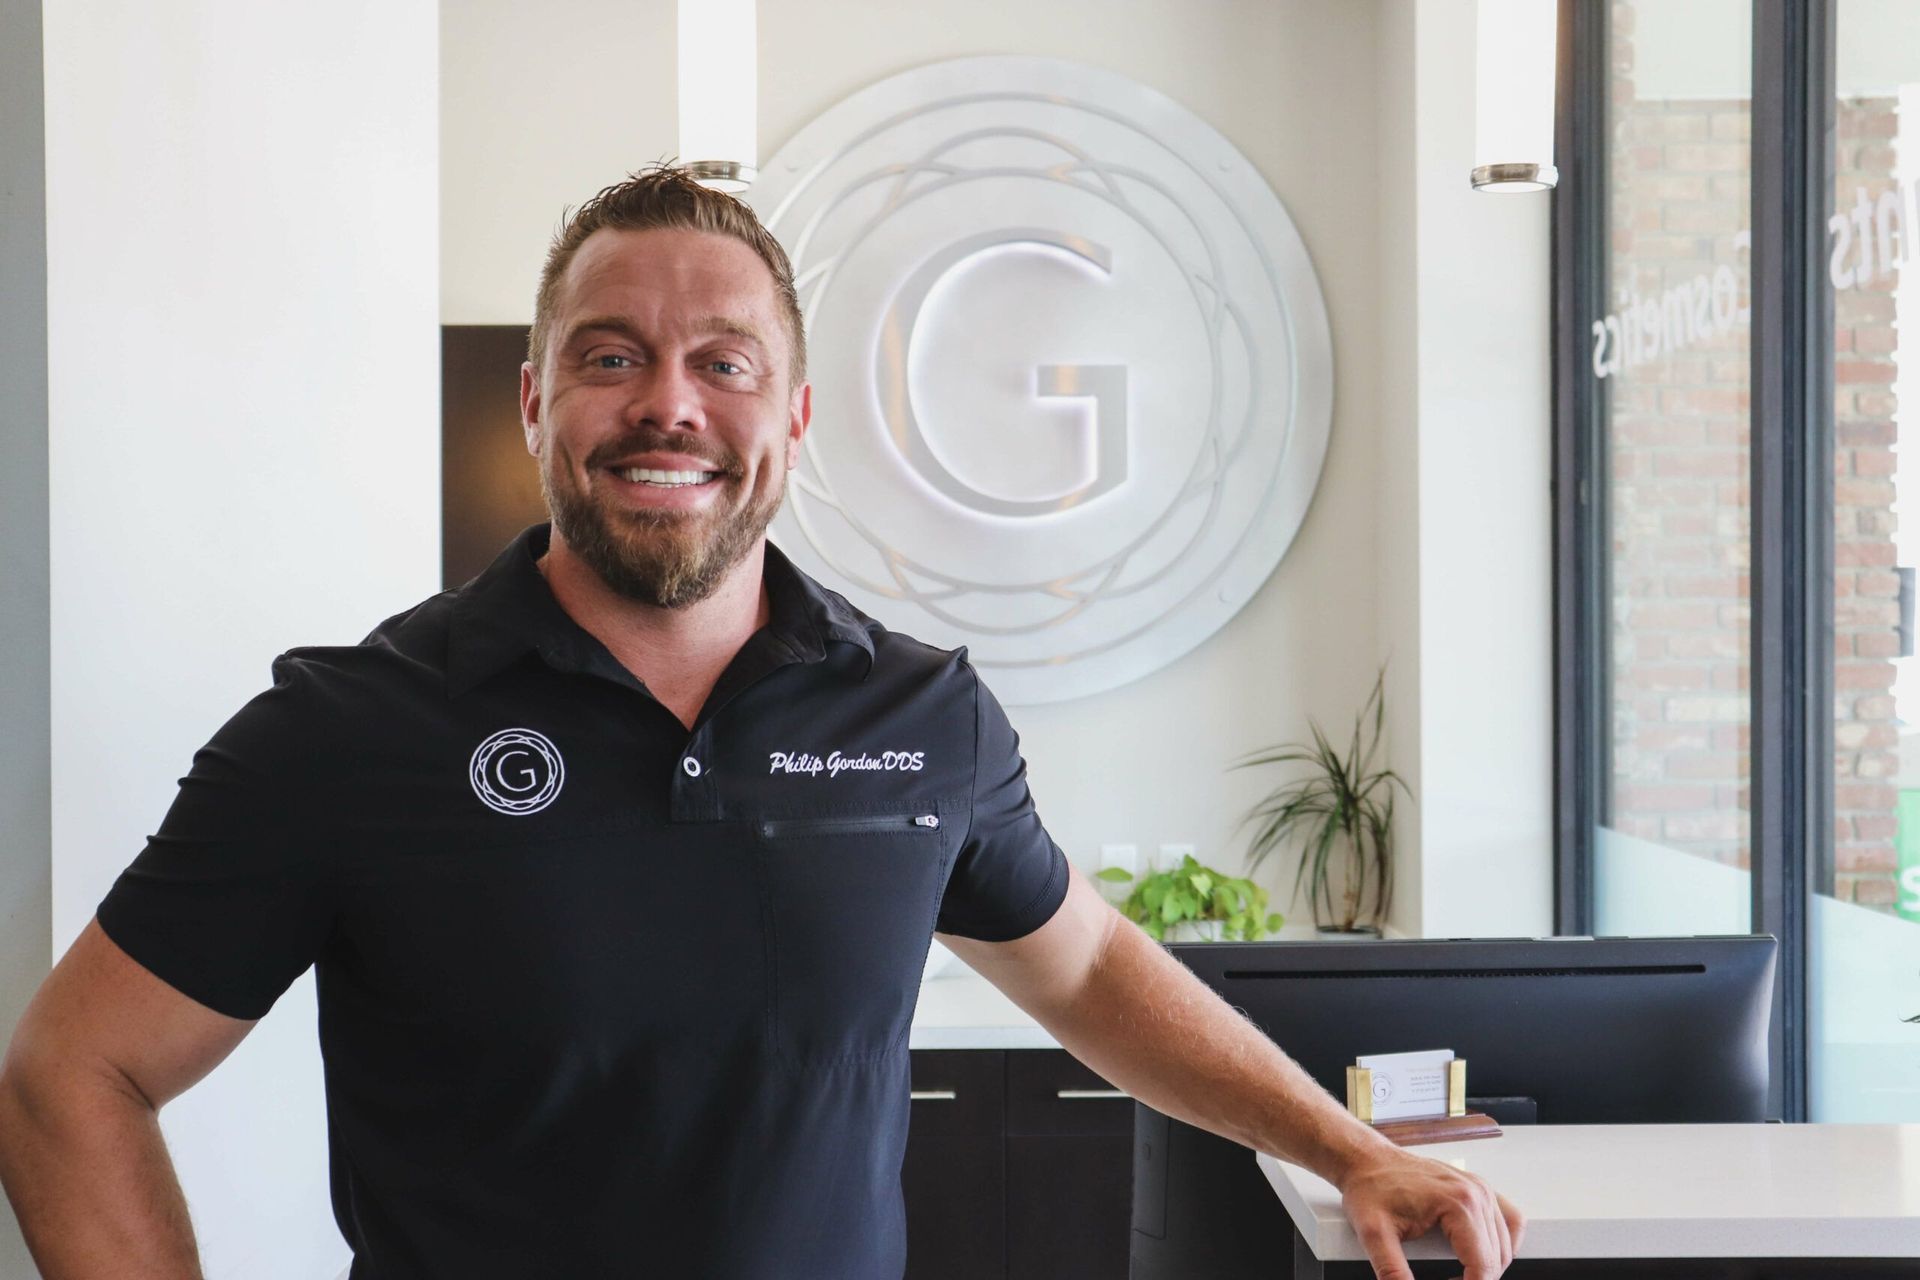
[{"x1": 0, "y1": 1077, "x2": 200, "y2": 1280}]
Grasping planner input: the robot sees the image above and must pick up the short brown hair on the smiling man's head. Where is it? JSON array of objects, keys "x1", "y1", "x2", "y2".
[{"x1": 526, "y1": 161, "x2": 806, "y2": 388}]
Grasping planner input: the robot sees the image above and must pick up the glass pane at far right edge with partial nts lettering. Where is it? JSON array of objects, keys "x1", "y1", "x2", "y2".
[{"x1": 1809, "y1": 0, "x2": 1920, "y2": 1121}]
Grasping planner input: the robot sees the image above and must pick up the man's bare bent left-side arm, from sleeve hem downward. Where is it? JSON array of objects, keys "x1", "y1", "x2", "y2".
[{"x1": 0, "y1": 921, "x2": 253, "y2": 1280}]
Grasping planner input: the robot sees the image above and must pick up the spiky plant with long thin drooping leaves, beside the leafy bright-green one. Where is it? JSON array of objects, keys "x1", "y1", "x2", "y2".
[{"x1": 1233, "y1": 668, "x2": 1411, "y2": 936}]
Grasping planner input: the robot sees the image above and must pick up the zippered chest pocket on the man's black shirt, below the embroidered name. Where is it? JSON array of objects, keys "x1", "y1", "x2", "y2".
[{"x1": 753, "y1": 800, "x2": 954, "y2": 1067}]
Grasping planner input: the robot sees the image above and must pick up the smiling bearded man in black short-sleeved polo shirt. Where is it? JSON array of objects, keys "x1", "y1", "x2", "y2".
[{"x1": 0, "y1": 167, "x2": 1521, "y2": 1280}]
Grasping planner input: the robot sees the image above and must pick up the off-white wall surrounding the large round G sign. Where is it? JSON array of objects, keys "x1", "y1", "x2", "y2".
[{"x1": 442, "y1": 0, "x2": 1413, "y2": 921}]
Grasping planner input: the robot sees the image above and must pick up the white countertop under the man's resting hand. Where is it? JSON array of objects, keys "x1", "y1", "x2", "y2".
[{"x1": 1258, "y1": 1125, "x2": 1920, "y2": 1263}]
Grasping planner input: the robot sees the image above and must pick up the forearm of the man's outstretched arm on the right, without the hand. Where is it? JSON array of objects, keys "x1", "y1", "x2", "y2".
[{"x1": 1041, "y1": 917, "x2": 1392, "y2": 1186}]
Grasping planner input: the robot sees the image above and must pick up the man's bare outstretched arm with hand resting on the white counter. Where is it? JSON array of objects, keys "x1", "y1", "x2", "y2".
[{"x1": 941, "y1": 873, "x2": 1523, "y2": 1280}]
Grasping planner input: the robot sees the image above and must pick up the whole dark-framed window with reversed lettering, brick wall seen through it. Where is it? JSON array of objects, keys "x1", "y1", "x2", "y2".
[{"x1": 1553, "y1": 0, "x2": 1920, "y2": 1121}]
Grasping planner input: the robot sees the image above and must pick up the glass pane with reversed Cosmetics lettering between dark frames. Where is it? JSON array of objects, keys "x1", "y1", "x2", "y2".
[{"x1": 1590, "y1": 0, "x2": 1753, "y2": 935}]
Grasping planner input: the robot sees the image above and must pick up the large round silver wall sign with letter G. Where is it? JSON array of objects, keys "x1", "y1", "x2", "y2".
[{"x1": 751, "y1": 58, "x2": 1332, "y2": 704}]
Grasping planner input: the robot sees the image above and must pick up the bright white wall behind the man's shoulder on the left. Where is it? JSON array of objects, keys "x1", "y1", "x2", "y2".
[{"x1": 44, "y1": 0, "x2": 440, "y2": 1280}]
